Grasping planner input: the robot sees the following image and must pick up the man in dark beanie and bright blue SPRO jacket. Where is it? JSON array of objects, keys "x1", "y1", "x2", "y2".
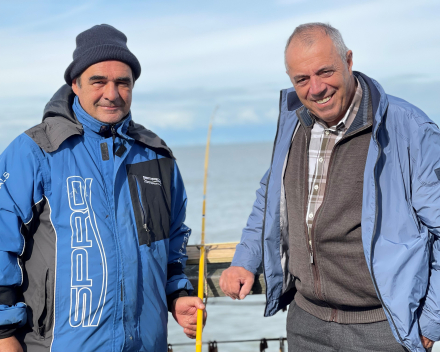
[{"x1": 0, "y1": 24, "x2": 206, "y2": 352}]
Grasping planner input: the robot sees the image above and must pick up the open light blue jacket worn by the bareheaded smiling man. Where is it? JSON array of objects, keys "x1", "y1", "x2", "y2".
[{"x1": 232, "y1": 72, "x2": 440, "y2": 352}]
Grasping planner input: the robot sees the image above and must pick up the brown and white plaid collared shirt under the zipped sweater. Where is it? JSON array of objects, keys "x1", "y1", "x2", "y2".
[{"x1": 306, "y1": 78, "x2": 362, "y2": 261}]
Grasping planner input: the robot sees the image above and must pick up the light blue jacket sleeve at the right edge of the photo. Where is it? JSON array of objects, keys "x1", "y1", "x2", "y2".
[{"x1": 412, "y1": 123, "x2": 440, "y2": 341}]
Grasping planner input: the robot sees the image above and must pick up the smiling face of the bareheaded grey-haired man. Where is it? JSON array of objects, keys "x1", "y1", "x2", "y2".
[{"x1": 286, "y1": 34, "x2": 355, "y2": 126}]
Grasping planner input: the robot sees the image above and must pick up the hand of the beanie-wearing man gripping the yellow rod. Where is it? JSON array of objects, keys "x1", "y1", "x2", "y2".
[{"x1": 171, "y1": 297, "x2": 208, "y2": 339}]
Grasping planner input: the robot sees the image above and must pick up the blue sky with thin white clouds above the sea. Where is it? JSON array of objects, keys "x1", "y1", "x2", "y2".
[{"x1": 0, "y1": 0, "x2": 440, "y2": 151}]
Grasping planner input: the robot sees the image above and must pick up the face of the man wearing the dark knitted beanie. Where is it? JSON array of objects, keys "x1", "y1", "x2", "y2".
[{"x1": 72, "y1": 61, "x2": 134, "y2": 124}]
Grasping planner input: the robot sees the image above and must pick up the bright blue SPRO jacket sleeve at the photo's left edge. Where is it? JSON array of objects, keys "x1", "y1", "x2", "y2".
[{"x1": 0, "y1": 135, "x2": 44, "y2": 338}]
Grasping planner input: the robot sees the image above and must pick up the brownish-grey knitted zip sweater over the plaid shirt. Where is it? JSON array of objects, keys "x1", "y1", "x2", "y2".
[{"x1": 284, "y1": 77, "x2": 386, "y2": 324}]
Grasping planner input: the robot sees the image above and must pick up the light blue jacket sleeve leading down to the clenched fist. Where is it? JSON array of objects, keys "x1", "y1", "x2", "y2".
[{"x1": 231, "y1": 169, "x2": 270, "y2": 274}]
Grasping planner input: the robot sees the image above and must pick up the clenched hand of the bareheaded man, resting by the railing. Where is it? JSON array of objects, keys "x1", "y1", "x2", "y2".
[{"x1": 220, "y1": 266, "x2": 255, "y2": 300}]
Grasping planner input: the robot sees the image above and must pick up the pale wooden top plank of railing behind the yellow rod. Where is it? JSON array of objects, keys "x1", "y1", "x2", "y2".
[{"x1": 186, "y1": 242, "x2": 238, "y2": 265}]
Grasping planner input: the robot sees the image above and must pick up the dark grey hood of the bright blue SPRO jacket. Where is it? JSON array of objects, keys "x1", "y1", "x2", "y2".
[{"x1": 25, "y1": 84, "x2": 174, "y2": 159}]
